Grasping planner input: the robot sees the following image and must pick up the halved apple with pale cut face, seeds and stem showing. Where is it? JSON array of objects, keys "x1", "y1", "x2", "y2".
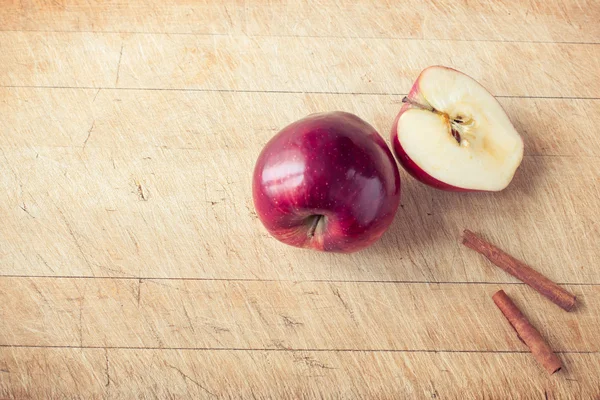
[{"x1": 391, "y1": 66, "x2": 523, "y2": 191}]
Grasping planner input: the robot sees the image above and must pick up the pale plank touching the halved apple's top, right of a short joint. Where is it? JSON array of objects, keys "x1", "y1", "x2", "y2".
[{"x1": 118, "y1": 35, "x2": 600, "y2": 98}]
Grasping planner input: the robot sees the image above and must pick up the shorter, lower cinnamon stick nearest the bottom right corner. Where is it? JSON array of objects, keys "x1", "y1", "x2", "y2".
[{"x1": 492, "y1": 290, "x2": 562, "y2": 375}]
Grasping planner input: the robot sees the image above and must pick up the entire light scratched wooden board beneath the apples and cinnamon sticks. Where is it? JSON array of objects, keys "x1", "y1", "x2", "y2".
[{"x1": 0, "y1": 0, "x2": 600, "y2": 399}]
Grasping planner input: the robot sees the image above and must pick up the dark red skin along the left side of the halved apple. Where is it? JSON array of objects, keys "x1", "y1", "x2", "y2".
[{"x1": 391, "y1": 67, "x2": 480, "y2": 192}]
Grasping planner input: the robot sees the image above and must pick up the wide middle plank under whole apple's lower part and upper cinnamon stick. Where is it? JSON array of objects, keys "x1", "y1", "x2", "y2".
[{"x1": 0, "y1": 148, "x2": 600, "y2": 283}]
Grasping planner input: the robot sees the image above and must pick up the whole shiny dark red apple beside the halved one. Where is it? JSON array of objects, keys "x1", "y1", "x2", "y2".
[{"x1": 252, "y1": 111, "x2": 400, "y2": 253}]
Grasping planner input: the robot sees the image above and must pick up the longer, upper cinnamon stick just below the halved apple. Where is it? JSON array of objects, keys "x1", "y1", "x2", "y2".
[{"x1": 463, "y1": 229, "x2": 576, "y2": 311}]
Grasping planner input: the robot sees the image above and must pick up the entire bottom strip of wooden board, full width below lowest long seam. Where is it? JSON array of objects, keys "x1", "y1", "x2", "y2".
[{"x1": 0, "y1": 348, "x2": 600, "y2": 400}]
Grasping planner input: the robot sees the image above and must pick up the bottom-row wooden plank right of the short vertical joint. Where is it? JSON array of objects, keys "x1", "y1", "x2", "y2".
[{"x1": 110, "y1": 350, "x2": 600, "y2": 399}]
